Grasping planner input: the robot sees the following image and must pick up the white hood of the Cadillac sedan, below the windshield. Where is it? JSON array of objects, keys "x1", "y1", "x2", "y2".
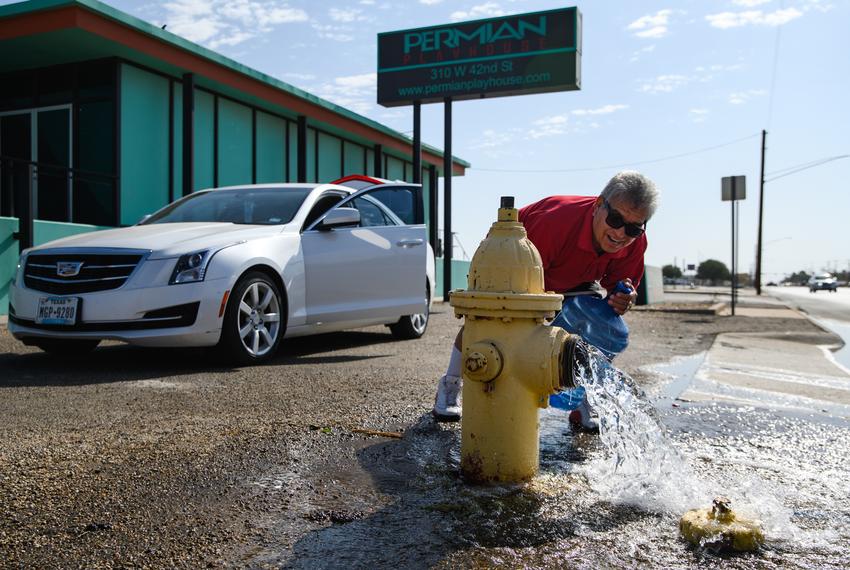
[{"x1": 33, "y1": 222, "x2": 284, "y2": 259}]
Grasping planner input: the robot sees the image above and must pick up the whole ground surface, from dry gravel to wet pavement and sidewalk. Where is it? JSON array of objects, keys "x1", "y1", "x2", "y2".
[{"x1": 0, "y1": 290, "x2": 850, "y2": 568}]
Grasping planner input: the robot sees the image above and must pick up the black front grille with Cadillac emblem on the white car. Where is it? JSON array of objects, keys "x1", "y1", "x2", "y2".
[{"x1": 24, "y1": 253, "x2": 142, "y2": 295}]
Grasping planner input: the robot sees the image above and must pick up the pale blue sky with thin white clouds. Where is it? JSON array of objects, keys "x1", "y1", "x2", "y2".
[{"x1": 9, "y1": 0, "x2": 850, "y2": 281}]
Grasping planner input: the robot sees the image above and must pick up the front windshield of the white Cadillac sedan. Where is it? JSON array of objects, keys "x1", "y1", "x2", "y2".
[{"x1": 142, "y1": 186, "x2": 313, "y2": 225}]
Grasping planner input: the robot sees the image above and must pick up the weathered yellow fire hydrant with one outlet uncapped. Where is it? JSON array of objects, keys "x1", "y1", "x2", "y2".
[{"x1": 450, "y1": 197, "x2": 576, "y2": 483}]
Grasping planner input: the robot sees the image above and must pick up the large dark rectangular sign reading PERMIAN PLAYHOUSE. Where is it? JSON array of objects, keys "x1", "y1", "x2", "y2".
[{"x1": 378, "y1": 8, "x2": 581, "y2": 107}]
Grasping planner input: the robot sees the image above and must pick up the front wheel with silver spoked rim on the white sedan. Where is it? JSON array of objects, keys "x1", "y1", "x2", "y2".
[{"x1": 219, "y1": 272, "x2": 286, "y2": 364}]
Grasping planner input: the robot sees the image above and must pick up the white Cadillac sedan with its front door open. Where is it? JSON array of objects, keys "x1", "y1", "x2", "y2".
[{"x1": 8, "y1": 176, "x2": 434, "y2": 364}]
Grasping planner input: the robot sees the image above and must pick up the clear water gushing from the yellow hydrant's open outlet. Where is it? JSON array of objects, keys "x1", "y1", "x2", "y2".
[{"x1": 564, "y1": 343, "x2": 798, "y2": 538}]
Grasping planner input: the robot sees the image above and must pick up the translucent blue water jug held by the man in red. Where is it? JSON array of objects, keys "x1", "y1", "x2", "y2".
[{"x1": 549, "y1": 281, "x2": 632, "y2": 410}]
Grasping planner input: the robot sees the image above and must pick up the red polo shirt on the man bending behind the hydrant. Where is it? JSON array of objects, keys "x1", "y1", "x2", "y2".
[{"x1": 519, "y1": 196, "x2": 647, "y2": 293}]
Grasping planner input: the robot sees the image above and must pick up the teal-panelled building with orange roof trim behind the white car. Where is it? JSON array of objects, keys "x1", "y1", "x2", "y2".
[{"x1": 0, "y1": 0, "x2": 469, "y2": 314}]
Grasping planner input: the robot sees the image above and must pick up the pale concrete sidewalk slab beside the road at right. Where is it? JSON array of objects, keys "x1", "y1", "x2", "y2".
[{"x1": 679, "y1": 290, "x2": 850, "y2": 417}]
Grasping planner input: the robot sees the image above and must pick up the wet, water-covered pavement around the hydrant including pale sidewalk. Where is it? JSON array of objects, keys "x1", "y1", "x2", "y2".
[{"x1": 242, "y1": 290, "x2": 850, "y2": 568}]
